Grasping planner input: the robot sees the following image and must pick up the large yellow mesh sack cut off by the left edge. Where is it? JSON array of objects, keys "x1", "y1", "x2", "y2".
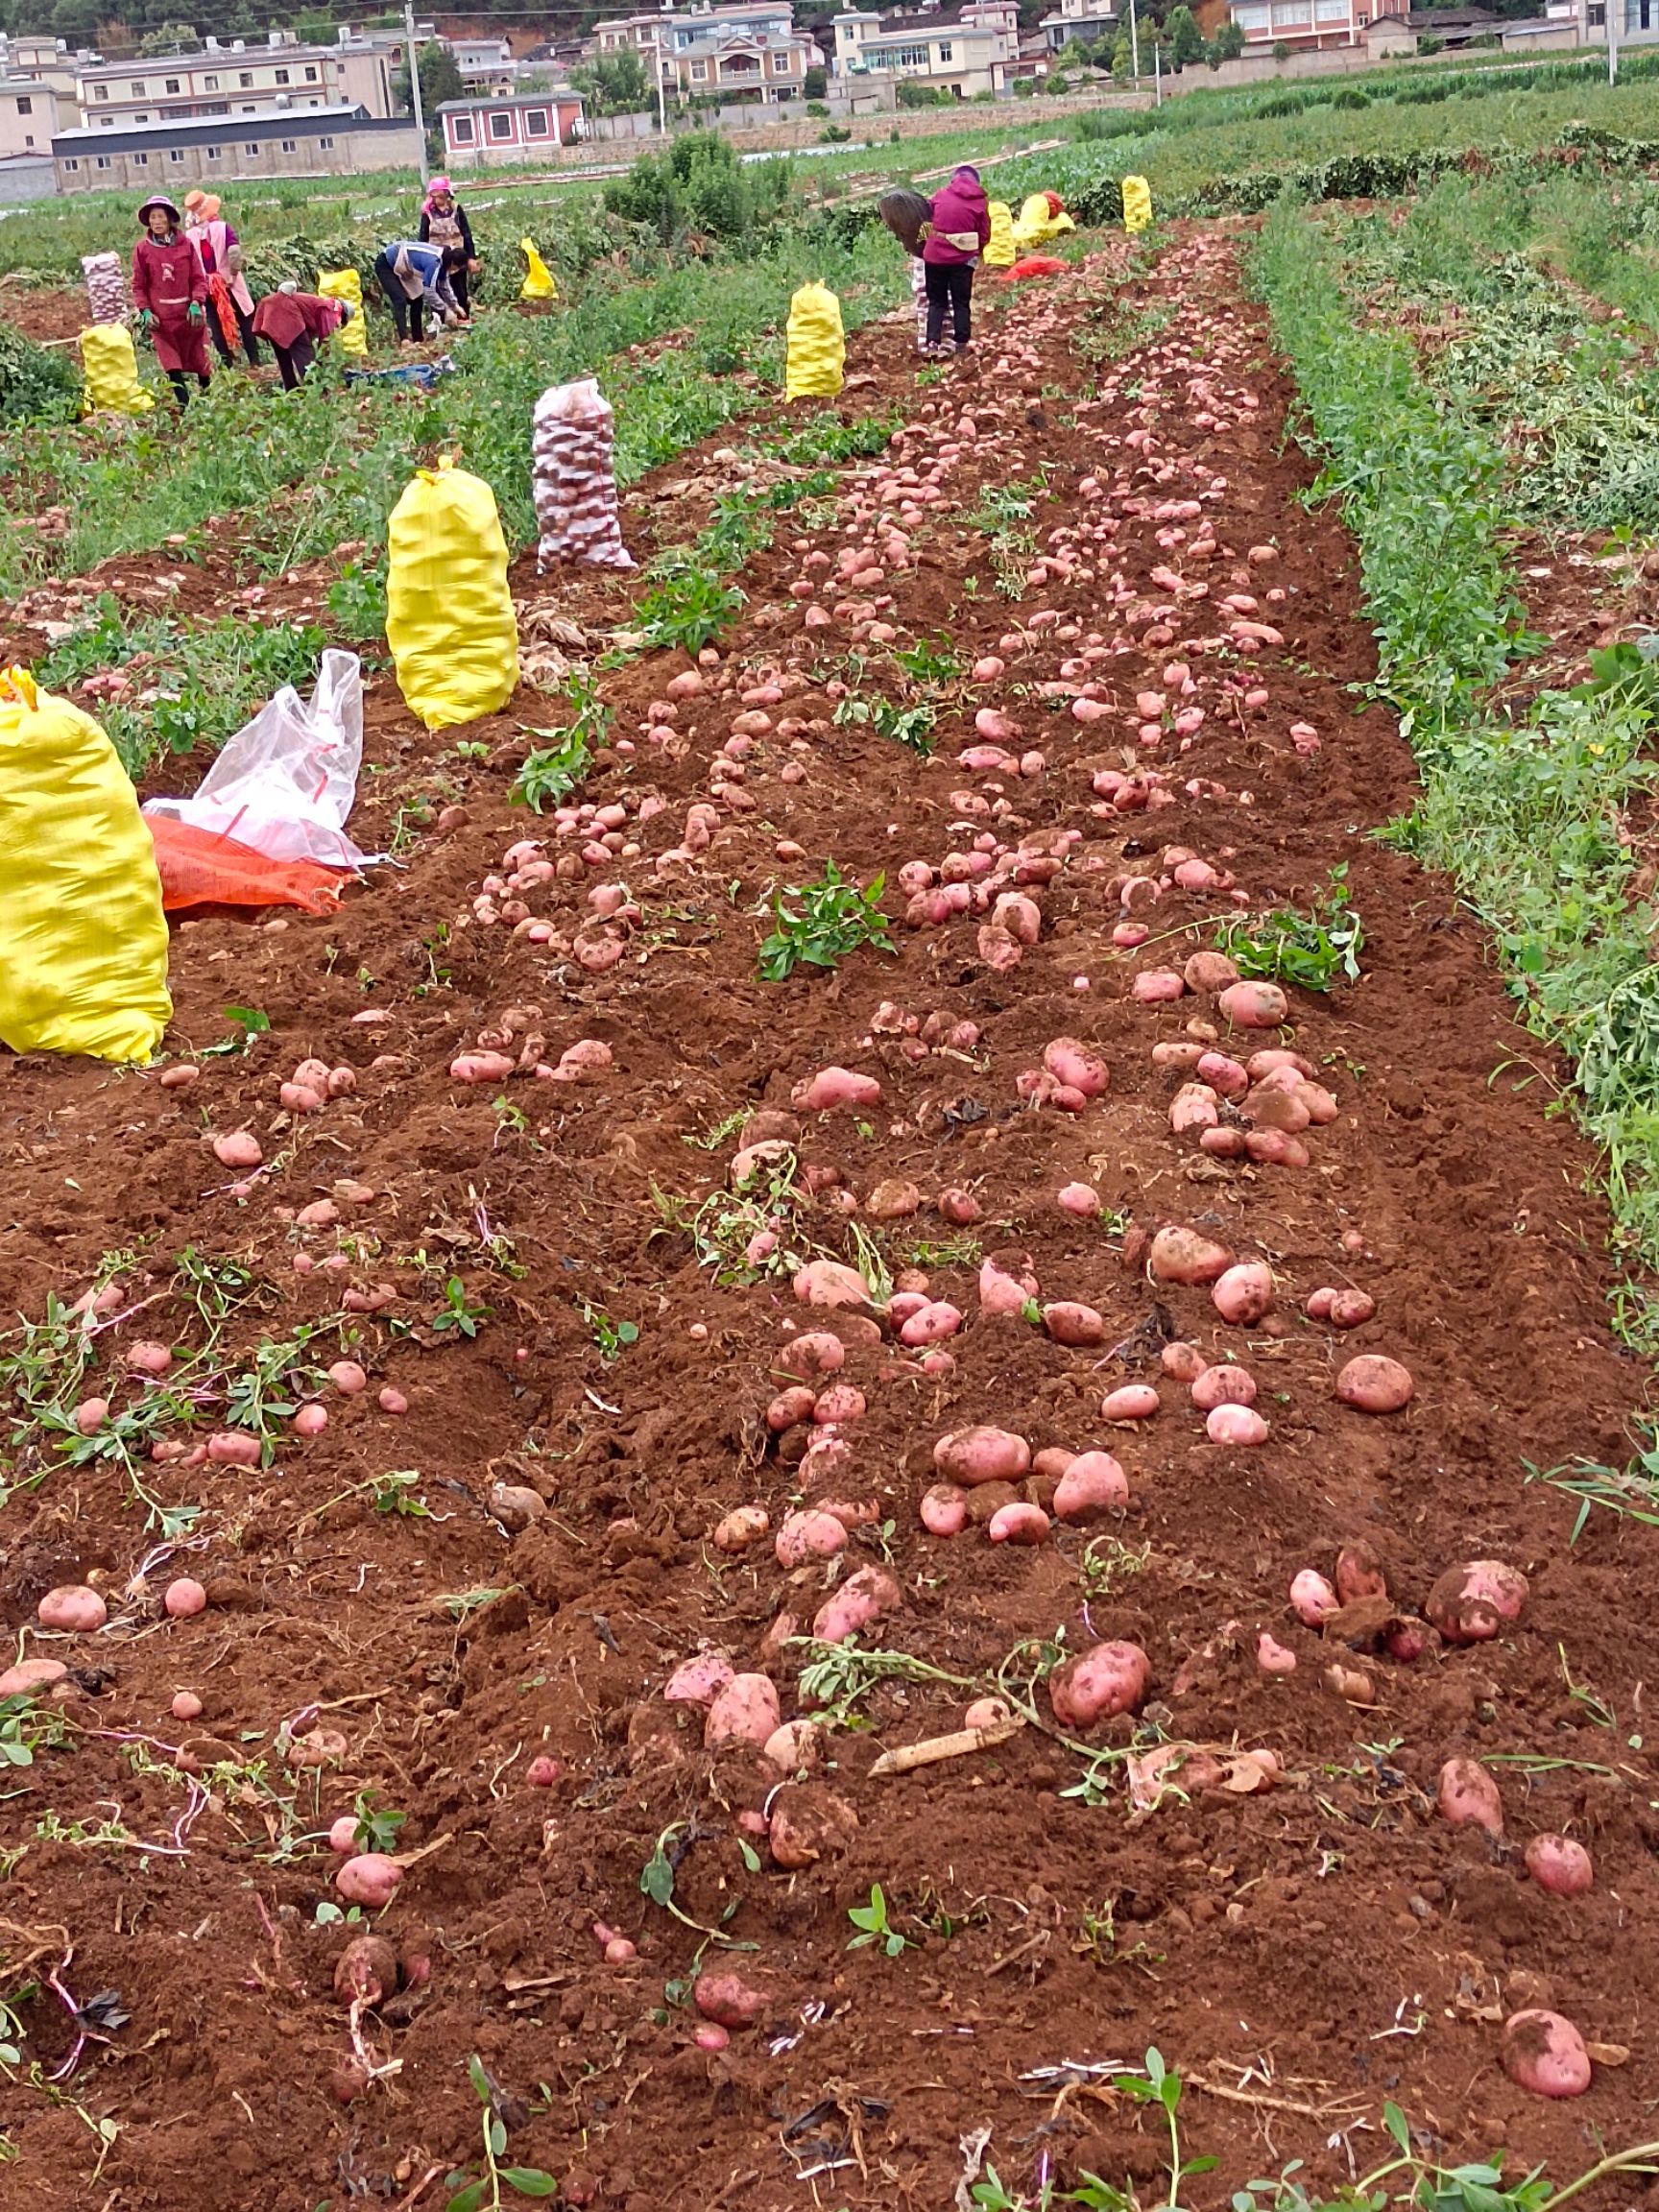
[{"x1": 0, "y1": 663, "x2": 173, "y2": 1060}]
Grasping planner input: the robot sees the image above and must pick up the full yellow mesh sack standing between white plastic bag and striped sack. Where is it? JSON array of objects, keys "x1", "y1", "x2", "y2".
[{"x1": 385, "y1": 458, "x2": 517, "y2": 730}]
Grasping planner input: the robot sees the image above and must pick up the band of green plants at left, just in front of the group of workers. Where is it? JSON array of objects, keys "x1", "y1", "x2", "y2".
[{"x1": 0, "y1": 216, "x2": 904, "y2": 595}]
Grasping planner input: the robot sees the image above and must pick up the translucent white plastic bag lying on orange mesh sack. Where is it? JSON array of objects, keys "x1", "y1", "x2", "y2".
[{"x1": 144, "y1": 648, "x2": 373, "y2": 867}]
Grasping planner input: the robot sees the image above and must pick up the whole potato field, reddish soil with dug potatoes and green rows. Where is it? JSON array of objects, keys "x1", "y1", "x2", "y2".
[{"x1": 0, "y1": 66, "x2": 1659, "y2": 2212}]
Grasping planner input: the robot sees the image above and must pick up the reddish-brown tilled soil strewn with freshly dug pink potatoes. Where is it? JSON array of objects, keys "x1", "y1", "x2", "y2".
[{"x1": 0, "y1": 232, "x2": 1659, "y2": 2212}]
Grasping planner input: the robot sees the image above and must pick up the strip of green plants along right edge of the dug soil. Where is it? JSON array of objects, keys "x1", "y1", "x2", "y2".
[{"x1": 1254, "y1": 204, "x2": 1659, "y2": 1354}]
